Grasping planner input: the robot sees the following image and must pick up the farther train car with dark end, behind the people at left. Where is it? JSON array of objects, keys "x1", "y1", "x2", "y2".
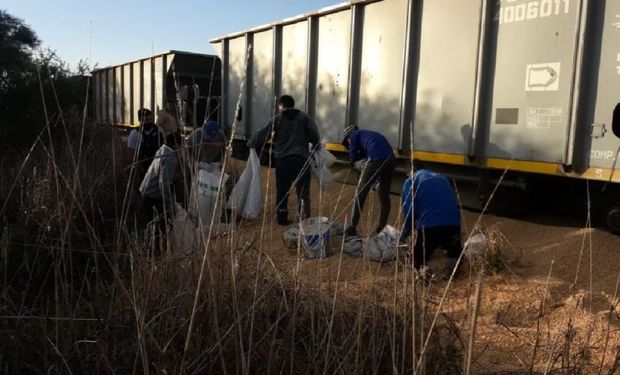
[{"x1": 92, "y1": 51, "x2": 222, "y2": 127}]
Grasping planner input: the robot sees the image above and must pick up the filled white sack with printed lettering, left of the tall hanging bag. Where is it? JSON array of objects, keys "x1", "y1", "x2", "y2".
[{"x1": 190, "y1": 165, "x2": 229, "y2": 226}]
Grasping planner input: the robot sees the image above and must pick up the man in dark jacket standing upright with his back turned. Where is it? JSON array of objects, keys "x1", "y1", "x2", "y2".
[{"x1": 248, "y1": 95, "x2": 320, "y2": 225}]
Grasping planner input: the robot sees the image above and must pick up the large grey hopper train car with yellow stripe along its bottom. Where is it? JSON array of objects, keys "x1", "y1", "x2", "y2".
[{"x1": 211, "y1": 0, "x2": 620, "y2": 230}]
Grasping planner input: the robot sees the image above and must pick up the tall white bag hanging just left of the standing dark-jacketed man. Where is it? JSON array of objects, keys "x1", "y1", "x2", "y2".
[{"x1": 226, "y1": 149, "x2": 262, "y2": 220}]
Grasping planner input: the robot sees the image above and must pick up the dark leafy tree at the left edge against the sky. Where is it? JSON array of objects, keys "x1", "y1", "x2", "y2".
[{"x1": 0, "y1": 9, "x2": 86, "y2": 147}]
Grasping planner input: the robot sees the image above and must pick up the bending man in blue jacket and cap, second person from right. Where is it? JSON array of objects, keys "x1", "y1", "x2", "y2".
[{"x1": 342, "y1": 125, "x2": 395, "y2": 236}]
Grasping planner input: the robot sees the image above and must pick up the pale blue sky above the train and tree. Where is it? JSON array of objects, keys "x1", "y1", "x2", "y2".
[{"x1": 0, "y1": 0, "x2": 344, "y2": 69}]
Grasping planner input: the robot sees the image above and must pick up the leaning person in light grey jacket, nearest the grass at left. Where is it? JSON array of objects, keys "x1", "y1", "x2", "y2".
[{"x1": 139, "y1": 133, "x2": 183, "y2": 252}]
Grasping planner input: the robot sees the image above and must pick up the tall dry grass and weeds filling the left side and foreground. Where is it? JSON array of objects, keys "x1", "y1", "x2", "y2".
[{"x1": 0, "y1": 62, "x2": 620, "y2": 374}]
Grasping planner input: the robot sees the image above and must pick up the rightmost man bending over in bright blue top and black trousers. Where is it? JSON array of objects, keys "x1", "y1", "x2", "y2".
[{"x1": 401, "y1": 169, "x2": 462, "y2": 276}]
